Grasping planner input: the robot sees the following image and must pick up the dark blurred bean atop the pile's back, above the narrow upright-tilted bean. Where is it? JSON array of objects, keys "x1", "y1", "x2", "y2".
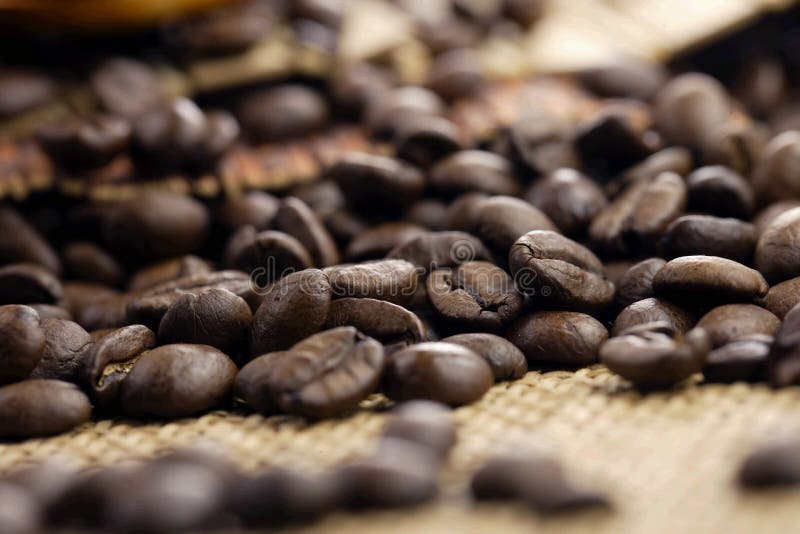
[{"x1": 327, "y1": 152, "x2": 425, "y2": 213}]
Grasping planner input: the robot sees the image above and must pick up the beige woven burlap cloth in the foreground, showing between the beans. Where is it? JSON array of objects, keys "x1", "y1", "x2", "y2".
[{"x1": 0, "y1": 366, "x2": 800, "y2": 534}]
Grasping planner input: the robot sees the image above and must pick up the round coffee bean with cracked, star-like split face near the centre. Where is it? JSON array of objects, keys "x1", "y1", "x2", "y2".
[{"x1": 426, "y1": 261, "x2": 522, "y2": 332}]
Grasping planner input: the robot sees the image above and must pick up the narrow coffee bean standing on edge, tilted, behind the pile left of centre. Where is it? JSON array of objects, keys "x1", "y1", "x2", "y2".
[{"x1": 275, "y1": 197, "x2": 339, "y2": 267}]
